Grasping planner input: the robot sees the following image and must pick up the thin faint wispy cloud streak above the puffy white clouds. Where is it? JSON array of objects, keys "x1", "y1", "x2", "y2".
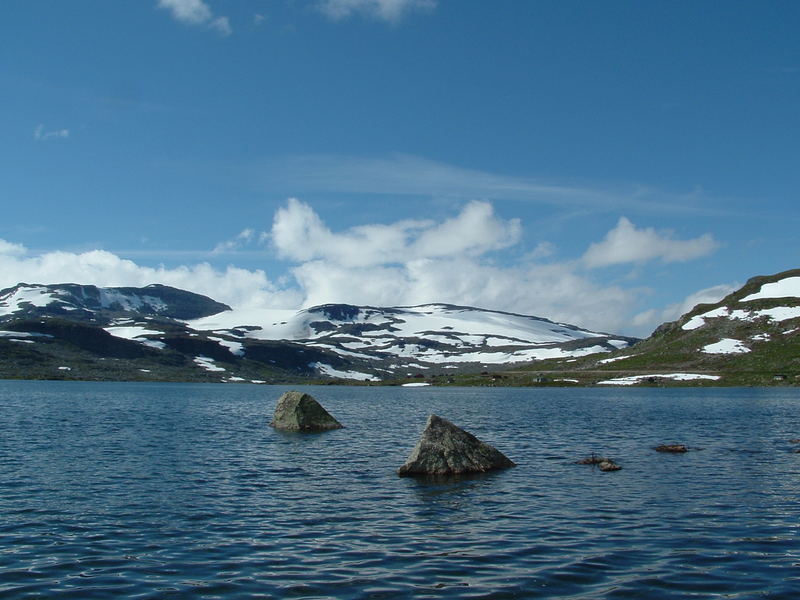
[{"x1": 251, "y1": 154, "x2": 727, "y2": 216}]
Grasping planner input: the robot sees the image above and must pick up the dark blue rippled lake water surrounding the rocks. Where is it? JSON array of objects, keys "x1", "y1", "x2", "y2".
[{"x1": 0, "y1": 382, "x2": 800, "y2": 599}]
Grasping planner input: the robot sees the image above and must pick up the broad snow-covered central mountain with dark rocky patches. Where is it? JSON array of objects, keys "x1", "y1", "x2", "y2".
[{"x1": 187, "y1": 304, "x2": 634, "y2": 375}]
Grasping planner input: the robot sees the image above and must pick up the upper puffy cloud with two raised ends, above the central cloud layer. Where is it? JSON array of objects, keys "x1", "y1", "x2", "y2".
[{"x1": 271, "y1": 198, "x2": 521, "y2": 267}]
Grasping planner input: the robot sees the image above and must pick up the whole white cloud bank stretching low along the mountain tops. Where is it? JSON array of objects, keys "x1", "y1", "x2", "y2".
[{"x1": 0, "y1": 199, "x2": 730, "y2": 335}]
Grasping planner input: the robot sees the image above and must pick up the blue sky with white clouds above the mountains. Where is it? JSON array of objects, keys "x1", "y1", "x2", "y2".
[{"x1": 0, "y1": 0, "x2": 800, "y2": 336}]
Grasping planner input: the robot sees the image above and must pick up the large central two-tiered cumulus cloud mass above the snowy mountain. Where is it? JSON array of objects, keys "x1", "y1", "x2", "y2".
[{"x1": 262, "y1": 199, "x2": 638, "y2": 330}]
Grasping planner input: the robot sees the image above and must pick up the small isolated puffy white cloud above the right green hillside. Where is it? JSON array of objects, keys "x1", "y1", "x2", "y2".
[{"x1": 583, "y1": 217, "x2": 719, "y2": 267}]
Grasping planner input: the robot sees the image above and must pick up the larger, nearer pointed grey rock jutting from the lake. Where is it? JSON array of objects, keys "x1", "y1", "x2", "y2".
[{"x1": 397, "y1": 415, "x2": 516, "y2": 477}]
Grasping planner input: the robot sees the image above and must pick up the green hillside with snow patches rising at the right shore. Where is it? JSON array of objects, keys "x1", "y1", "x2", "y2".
[{"x1": 494, "y1": 269, "x2": 800, "y2": 385}]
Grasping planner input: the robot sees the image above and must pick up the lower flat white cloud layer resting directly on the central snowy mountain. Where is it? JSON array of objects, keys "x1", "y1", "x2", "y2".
[{"x1": 293, "y1": 257, "x2": 636, "y2": 331}]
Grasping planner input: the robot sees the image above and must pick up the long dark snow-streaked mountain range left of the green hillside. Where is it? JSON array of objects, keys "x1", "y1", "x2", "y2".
[{"x1": 0, "y1": 284, "x2": 636, "y2": 382}]
